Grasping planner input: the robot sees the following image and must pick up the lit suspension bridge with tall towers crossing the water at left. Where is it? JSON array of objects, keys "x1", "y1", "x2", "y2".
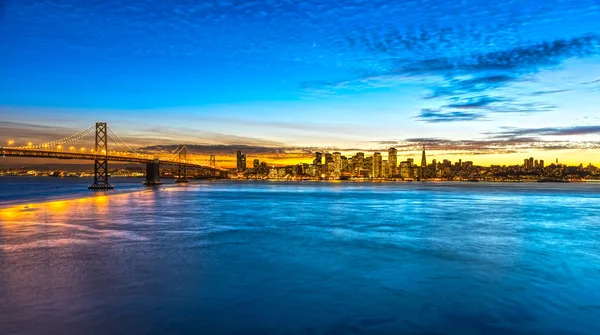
[{"x1": 0, "y1": 122, "x2": 228, "y2": 190}]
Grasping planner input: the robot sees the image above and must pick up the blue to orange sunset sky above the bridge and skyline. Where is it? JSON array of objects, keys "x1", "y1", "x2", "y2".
[{"x1": 0, "y1": 0, "x2": 600, "y2": 165}]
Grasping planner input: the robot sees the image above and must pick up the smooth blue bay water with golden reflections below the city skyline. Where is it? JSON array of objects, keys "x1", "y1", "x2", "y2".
[{"x1": 0, "y1": 179, "x2": 600, "y2": 335}]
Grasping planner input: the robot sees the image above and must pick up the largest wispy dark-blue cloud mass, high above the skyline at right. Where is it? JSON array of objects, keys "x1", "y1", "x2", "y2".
[{"x1": 302, "y1": 29, "x2": 600, "y2": 122}]
